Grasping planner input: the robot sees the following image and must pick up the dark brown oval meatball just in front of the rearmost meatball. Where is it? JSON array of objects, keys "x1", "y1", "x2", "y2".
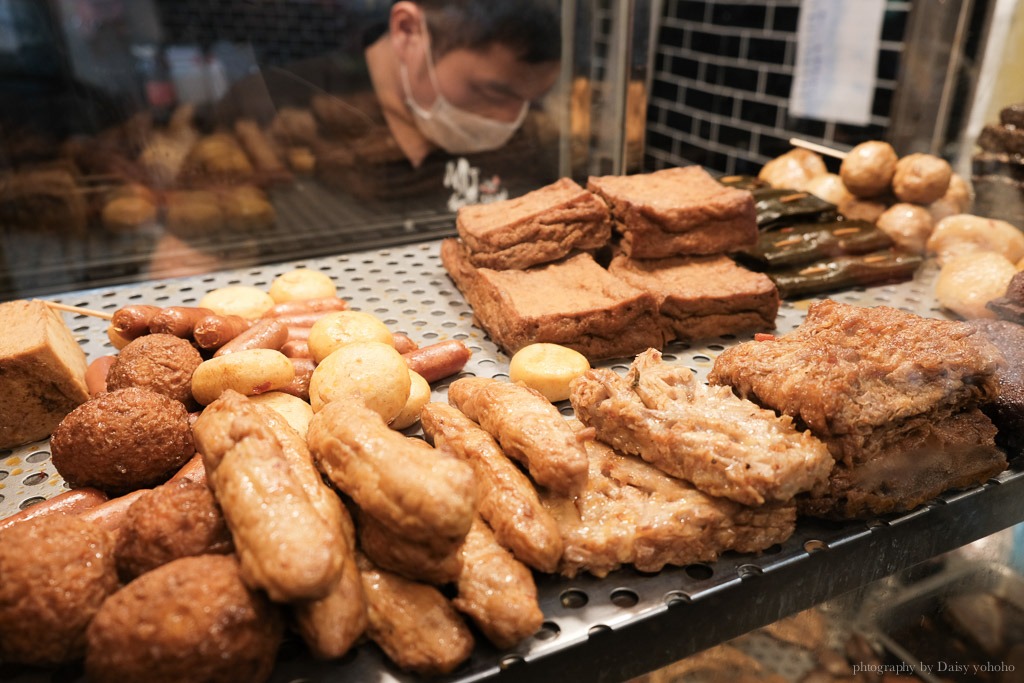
[{"x1": 50, "y1": 387, "x2": 196, "y2": 496}]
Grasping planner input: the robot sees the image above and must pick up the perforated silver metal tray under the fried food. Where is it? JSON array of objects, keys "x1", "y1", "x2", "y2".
[{"x1": 0, "y1": 241, "x2": 1024, "y2": 683}]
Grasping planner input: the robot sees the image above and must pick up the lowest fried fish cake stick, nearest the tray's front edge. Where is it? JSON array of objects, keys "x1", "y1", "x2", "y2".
[{"x1": 358, "y1": 555, "x2": 473, "y2": 676}]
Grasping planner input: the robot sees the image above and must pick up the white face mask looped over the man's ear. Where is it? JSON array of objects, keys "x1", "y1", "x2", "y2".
[{"x1": 400, "y1": 23, "x2": 529, "y2": 155}]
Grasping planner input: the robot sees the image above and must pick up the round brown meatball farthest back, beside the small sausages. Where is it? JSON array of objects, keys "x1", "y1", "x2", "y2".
[{"x1": 106, "y1": 334, "x2": 203, "y2": 404}]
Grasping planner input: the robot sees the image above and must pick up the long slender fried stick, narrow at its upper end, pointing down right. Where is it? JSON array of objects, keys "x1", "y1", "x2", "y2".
[{"x1": 420, "y1": 403, "x2": 562, "y2": 572}]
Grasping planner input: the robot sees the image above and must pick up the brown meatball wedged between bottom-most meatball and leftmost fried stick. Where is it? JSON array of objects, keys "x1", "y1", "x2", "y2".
[{"x1": 115, "y1": 479, "x2": 232, "y2": 581}]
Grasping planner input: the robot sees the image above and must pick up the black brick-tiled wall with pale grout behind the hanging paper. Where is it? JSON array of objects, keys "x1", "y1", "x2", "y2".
[{"x1": 644, "y1": 0, "x2": 910, "y2": 174}]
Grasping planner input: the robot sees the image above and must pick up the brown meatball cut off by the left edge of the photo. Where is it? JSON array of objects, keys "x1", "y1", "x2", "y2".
[{"x1": 0, "y1": 514, "x2": 118, "y2": 666}]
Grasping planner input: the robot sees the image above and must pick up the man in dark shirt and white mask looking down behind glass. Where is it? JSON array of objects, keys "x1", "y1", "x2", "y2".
[{"x1": 216, "y1": 0, "x2": 561, "y2": 208}]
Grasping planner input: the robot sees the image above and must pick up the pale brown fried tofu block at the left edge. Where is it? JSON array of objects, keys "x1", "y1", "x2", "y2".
[{"x1": 0, "y1": 301, "x2": 89, "y2": 449}]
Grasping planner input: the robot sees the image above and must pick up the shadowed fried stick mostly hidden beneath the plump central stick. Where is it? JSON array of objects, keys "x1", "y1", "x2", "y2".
[{"x1": 359, "y1": 515, "x2": 462, "y2": 586}]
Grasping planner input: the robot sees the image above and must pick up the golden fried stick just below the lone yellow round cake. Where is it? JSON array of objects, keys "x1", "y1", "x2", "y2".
[{"x1": 449, "y1": 377, "x2": 587, "y2": 496}]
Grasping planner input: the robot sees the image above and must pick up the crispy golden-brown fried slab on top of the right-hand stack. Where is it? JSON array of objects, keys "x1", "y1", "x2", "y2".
[{"x1": 708, "y1": 300, "x2": 1005, "y2": 437}]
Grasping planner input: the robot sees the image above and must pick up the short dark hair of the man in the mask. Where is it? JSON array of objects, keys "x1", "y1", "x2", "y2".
[{"x1": 416, "y1": 0, "x2": 562, "y2": 63}]
